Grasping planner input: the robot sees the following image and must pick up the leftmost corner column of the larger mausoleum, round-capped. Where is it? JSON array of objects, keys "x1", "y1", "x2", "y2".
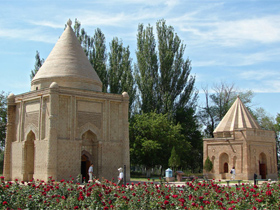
[{"x1": 3, "y1": 93, "x2": 16, "y2": 180}]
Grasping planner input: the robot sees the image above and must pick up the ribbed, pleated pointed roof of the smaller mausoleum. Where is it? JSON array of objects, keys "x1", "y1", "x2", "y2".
[{"x1": 214, "y1": 97, "x2": 261, "y2": 133}]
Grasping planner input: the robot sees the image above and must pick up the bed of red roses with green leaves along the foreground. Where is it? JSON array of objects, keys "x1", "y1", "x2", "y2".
[{"x1": 0, "y1": 176, "x2": 280, "y2": 210}]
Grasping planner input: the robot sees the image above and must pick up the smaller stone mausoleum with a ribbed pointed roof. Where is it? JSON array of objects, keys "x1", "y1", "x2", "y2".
[{"x1": 203, "y1": 97, "x2": 278, "y2": 180}]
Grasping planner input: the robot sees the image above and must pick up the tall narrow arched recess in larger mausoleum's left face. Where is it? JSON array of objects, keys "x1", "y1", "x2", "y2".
[{"x1": 23, "y1": 131, "x2": 35, "y2": 181}]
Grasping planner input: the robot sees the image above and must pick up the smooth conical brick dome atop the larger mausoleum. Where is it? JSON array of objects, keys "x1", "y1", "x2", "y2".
[{"x1": 31, "y1": 20, "x2": 102, "y2": 91}]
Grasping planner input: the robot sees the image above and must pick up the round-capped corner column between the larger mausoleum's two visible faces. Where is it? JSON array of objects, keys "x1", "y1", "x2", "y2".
[{"x1": 47, "y1": 82, "x2": 59, "y2": 180}]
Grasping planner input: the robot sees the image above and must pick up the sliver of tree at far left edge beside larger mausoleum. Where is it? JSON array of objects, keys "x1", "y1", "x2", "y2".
[{"x1": 0, "y1": 91, "x2": 7, "y2": 148}]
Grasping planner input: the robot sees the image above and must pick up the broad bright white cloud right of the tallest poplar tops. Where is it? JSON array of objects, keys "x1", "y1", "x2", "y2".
[{"x1": 172, "y1": 8, "x2": 280, "y2": 47}]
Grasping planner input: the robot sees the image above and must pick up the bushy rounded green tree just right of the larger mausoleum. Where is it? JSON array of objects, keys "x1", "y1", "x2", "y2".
[{"x1": 129, "y1": 112, "x2": 190, "y2": 176}]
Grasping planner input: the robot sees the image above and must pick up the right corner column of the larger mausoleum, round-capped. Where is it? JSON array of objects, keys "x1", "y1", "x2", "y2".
[{"x1": 120, "y1": 92, "x2": 130, "y2": 181}]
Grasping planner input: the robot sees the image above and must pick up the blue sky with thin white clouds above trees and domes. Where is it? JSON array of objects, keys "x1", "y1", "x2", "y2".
[{"x1": 0, "y1": 0, "x2": 280, "y2": 116}]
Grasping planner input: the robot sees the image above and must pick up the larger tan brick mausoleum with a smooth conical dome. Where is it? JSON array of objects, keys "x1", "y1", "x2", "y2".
[{"x1": 3, "y1": 20, "x2": 130, "y2": 181}]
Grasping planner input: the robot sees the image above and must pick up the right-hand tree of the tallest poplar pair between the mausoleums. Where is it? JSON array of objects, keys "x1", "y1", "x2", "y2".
[{"x1": 156, "y1": 20, "x2": 195, "y2": 113}]
